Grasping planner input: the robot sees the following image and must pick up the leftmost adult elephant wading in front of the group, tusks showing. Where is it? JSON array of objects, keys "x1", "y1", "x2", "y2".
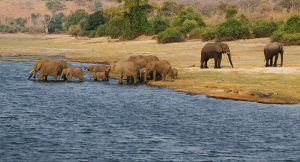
[{"x1": 28, "y1": 59, "x2": 68, "y2": 80}]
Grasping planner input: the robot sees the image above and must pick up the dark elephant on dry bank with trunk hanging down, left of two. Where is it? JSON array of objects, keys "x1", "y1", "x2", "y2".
[{"x1": 200, "y1": 42, "x2": 233, "y2": 68}]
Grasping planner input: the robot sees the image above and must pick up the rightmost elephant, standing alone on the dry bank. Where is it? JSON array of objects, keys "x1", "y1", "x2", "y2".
[{"x1": 264, "y1": 42, "x2": 284, "y2": 67}]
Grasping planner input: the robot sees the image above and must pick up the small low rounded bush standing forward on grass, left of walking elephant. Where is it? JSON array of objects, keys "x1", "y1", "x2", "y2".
[{"x1": 157, "y1": 29, "x2": 184, "y2": 43}]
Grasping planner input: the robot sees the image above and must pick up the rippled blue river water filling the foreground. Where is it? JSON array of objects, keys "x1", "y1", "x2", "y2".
[{"x1": 0, "y1": 62, "x2": 300, "y2": 162}]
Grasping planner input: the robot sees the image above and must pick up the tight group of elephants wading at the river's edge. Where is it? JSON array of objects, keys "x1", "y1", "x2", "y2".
[{"x1": 28, "y1": 55, "x2": 178, "y2": 84}]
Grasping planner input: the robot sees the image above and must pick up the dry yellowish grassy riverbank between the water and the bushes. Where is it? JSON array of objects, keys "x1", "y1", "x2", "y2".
[{"x1": 0, "y1": 34, "x2": 300, "y2": 104}]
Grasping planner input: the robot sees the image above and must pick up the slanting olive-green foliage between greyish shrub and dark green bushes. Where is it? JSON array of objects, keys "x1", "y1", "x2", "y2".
[{"x1": 64, "y1": 9, "x2": 89, "y2": 30}]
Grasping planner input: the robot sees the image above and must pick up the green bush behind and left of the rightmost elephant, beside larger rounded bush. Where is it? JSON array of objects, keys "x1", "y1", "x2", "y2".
[{"x1": 252, "y1": 21, "x2": 278, "y2": 38}]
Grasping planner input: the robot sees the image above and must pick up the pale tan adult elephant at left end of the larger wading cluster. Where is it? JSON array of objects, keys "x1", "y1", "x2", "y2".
[{"x1": 110, "y1": 61, "x2": 139, "y2": 84}]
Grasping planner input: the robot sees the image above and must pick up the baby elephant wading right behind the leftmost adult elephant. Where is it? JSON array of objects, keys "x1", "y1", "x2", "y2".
[{"x1": 61, "y1": 67, "x2": 84, "y2": 82}]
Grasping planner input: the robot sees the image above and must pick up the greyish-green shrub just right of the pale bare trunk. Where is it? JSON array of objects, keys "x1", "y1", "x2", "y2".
[{"x1": 48, "y1": 13, "x2": 65, "y2": 33}]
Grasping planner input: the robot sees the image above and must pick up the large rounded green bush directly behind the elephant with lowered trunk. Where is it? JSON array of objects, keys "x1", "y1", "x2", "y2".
[{"x1": 216, "y1": 19, "x2": 251, "y2": 41}]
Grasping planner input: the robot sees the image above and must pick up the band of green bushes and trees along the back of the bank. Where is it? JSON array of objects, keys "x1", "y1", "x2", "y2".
[{"x1": 0, "y1": 0, "x2": 300, "y2": 45}]
